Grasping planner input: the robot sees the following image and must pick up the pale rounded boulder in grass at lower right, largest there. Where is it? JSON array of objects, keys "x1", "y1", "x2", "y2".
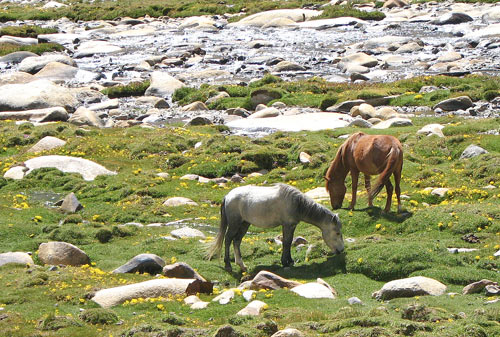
[{"x1": 372, "y1": 276, "x2": 446, "y2": 300}]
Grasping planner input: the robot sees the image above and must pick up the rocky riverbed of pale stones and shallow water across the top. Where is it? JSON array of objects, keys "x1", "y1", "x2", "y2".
[{"x1": 0, "y1": 2, "x2": 500, "y2": 135}]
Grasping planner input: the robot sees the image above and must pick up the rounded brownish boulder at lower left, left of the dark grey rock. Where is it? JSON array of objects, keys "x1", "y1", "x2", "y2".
[{"x1": 38, "y1": 241, "x2": 90, "y2": 266}]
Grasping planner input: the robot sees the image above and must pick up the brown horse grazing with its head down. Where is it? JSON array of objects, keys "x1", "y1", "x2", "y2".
[{"x1": 325, "y1": 132, "x2": 403, "y2": 213}]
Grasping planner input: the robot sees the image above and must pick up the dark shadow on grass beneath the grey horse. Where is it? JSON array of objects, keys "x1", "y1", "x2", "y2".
[{"x1": 251, "y1": 253, "x2": 347, "y2": 280}]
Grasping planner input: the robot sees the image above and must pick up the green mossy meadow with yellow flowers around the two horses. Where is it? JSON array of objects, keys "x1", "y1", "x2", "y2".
[{"x1": 0, "y1": 113, "x2": 500, "y2": 336}]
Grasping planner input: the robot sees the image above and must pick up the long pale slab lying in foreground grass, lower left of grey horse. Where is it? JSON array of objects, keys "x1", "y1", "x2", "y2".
[{"x1": 92, "y1": 279, "x2": 195, "y2": 308}]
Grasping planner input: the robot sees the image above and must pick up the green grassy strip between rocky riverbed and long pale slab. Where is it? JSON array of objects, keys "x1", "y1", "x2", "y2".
[{"x1": 173, "y1": 75, "x2": 500, "y2": 109}]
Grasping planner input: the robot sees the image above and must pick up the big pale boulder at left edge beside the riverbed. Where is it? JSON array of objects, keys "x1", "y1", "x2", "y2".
[{"x1": 0, "y1": 80, "x2": 79, "y2": 111}]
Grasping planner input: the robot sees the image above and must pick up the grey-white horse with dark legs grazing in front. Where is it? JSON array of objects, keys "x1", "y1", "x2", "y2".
[{"x1": 207, "y1": 184, "x2": 344, "y2": 271}]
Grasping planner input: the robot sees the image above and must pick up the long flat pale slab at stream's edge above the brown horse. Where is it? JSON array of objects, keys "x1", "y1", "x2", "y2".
[{"x1": 226, "y1": 112, "x2": 352, "y2": 132}]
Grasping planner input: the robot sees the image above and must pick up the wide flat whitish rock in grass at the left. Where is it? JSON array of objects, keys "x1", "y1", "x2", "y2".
[{"x1": 4, "y1": 155, "x2": 116, "y2": 181}]
